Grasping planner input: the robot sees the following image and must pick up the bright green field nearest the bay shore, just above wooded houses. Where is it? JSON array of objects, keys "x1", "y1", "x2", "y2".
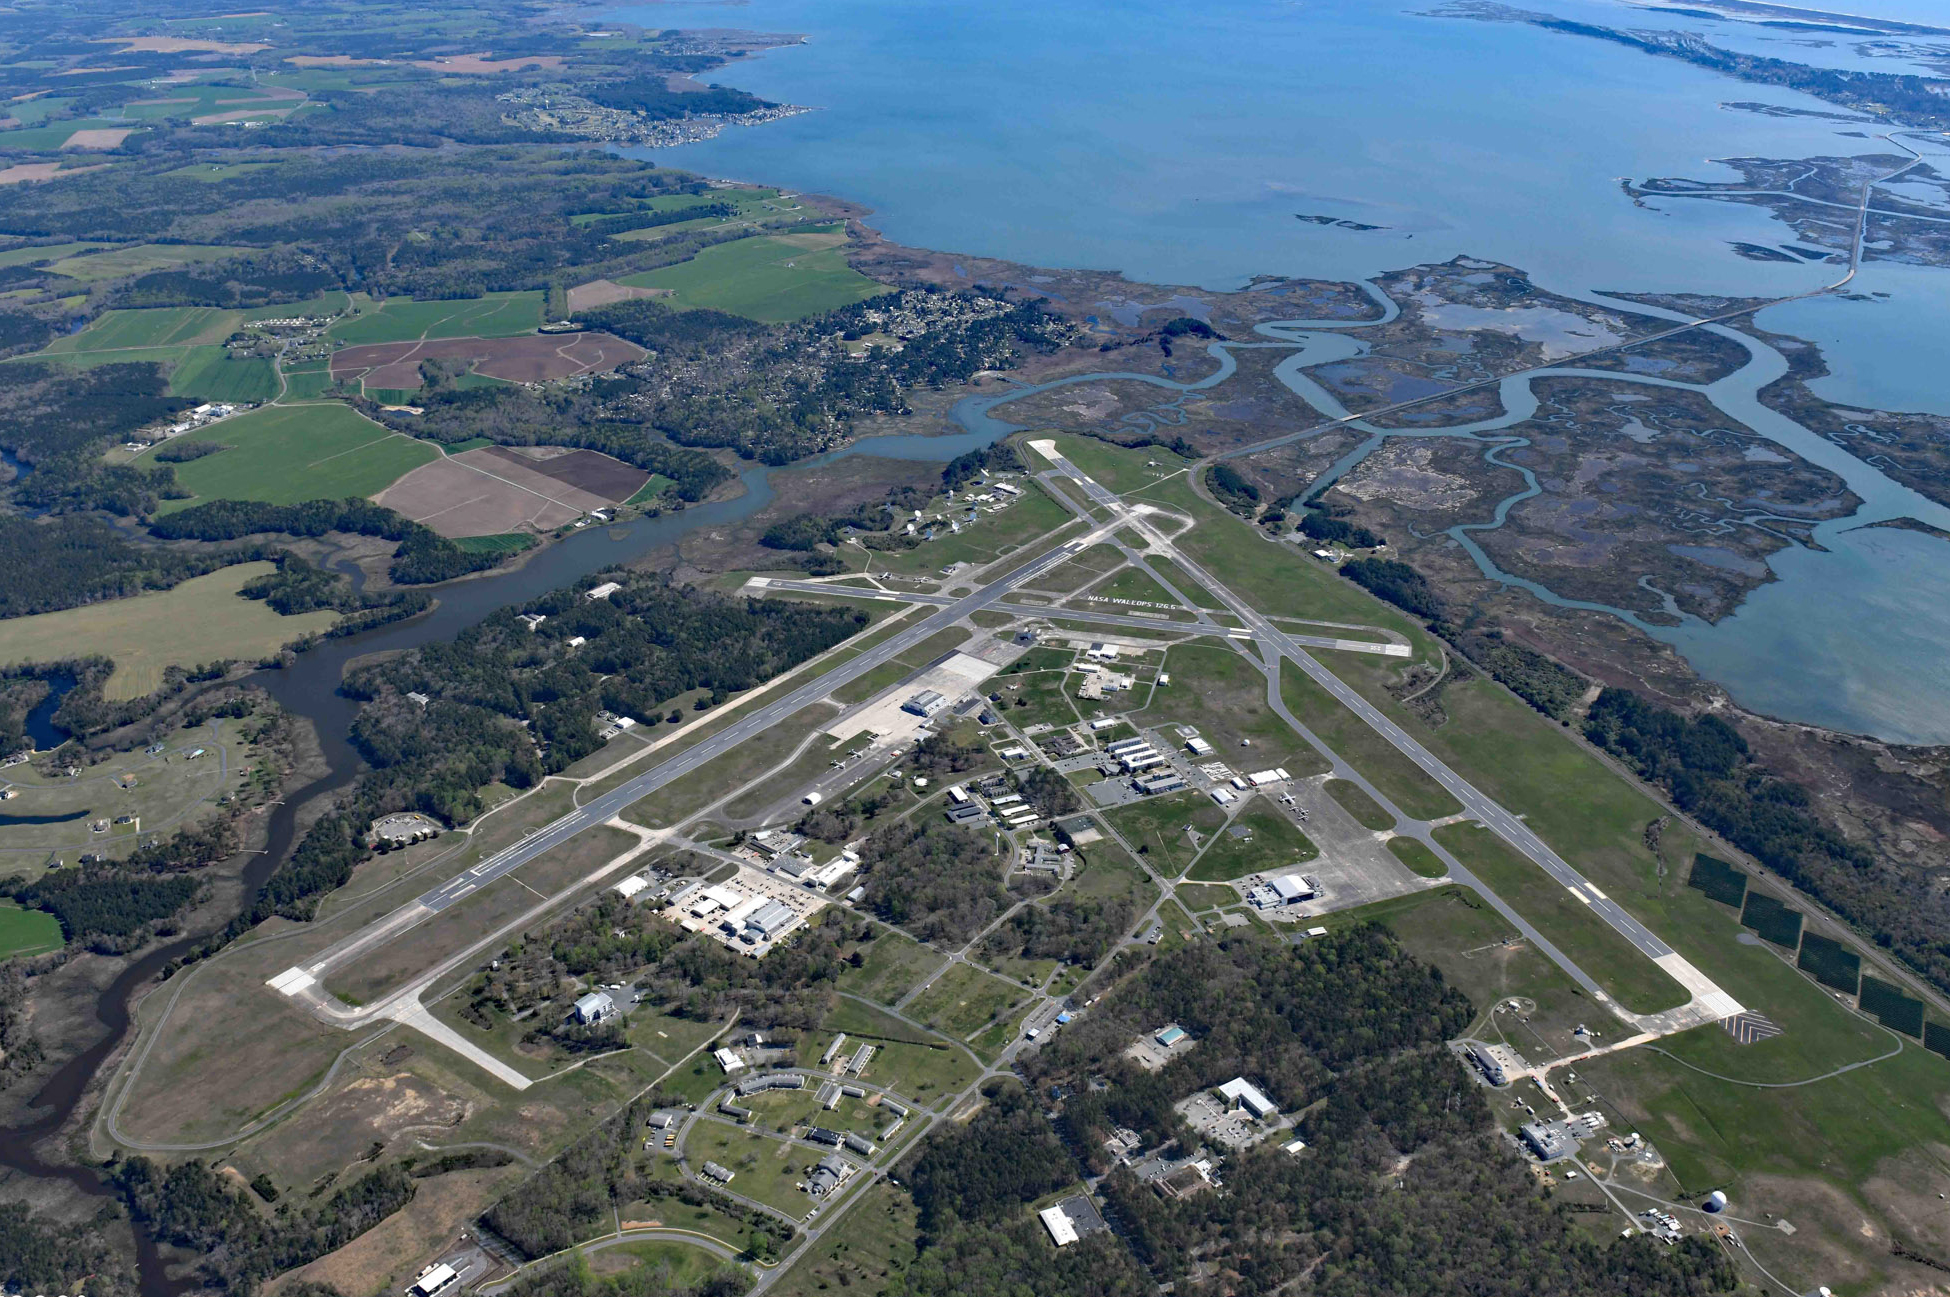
[{"x1": 618, "y1": 234, "x2": 885, "y2": 324}]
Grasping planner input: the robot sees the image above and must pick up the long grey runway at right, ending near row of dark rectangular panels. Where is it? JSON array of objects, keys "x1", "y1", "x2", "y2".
[{"x1": 1030, "y1": 441, "x2": 1741, "y2": 1022}]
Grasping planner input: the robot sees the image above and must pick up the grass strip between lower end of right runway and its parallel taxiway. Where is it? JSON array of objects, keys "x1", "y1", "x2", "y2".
[{"x1": 1435, "y1": 823, "x2": 1689, "y2": 1014}]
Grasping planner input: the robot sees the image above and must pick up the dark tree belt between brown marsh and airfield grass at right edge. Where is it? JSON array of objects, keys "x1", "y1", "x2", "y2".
[{"x1": 1583, "y1": 688, "x2": 1950, "y2": 991}]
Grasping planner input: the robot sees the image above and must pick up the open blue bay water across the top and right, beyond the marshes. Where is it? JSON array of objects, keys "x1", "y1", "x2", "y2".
[{"x1": 612, "y1": 0, "x2": 1950, "y2": 741}]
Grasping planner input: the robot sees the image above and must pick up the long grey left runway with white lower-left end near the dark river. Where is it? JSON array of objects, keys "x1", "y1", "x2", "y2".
[{"x1": 271, "y1": 525, "x2": 1112, "y2": 1028}]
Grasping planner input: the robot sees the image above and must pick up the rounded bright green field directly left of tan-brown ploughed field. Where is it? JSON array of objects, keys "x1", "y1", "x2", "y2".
[{"x1": 162, "y1": 406, "x2": 439, "y2": 513}]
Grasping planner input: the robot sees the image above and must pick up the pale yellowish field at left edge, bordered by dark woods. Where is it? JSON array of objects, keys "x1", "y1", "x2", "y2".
[{"x1": 0, "y1": 557, "x2": 339, "y2": 702}]
